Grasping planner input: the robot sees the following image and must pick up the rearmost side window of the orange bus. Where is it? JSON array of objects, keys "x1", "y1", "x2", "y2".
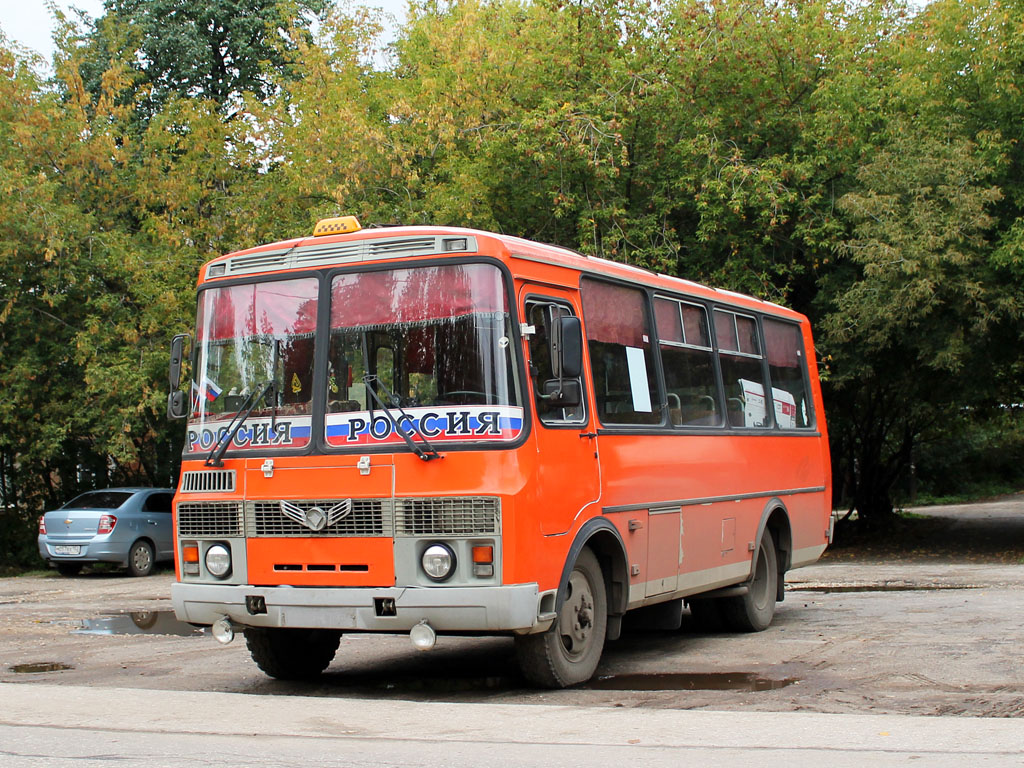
[{"x1": 764, "y1": 317, "x2": 814, "y2": 429}]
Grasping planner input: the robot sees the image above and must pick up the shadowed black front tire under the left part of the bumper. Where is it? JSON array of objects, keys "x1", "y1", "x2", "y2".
[{"x1": 245, "y1": 627, "x2": 341, "y2": 680}]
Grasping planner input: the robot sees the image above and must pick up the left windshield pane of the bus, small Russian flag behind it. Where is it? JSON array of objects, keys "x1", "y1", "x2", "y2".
[{"x1": 187, "y1": 278, "x2": 318, "y2": 451}]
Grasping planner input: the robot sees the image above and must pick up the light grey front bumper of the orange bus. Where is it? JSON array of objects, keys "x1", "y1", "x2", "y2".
[{"x1": 171, "y1": 583, "x2": 552, "y2": 633}]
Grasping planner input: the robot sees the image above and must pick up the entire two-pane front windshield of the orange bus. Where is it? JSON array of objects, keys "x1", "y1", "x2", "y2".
[{"x1": 186, "y1": 263, "x2": 523, "y2": 452}]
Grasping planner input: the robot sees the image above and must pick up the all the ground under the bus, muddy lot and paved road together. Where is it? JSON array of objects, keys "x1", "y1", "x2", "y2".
[{"x1": 0, "y1": 496, "x2": 1024, "y2": 768}]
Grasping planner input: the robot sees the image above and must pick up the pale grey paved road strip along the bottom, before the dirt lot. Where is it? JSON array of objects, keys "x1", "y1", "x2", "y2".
[{"x1": 6, "y1": 683, "x2": 1024, "y2": 768}]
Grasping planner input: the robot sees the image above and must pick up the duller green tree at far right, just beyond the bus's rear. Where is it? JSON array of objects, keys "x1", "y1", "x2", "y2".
[{"x1": 817, "y1": 3, "x2": 1024, "y2": 523}]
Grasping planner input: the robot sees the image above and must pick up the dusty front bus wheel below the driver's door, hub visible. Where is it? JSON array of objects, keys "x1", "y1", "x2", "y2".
[{"x1": 515, "y1": 548, "x2": 608, "y2": 688}]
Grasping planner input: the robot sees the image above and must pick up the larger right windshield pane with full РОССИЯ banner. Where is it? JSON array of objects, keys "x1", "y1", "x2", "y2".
[{"x1": 325, "y1": 264, "x2": 522, "y2": 446}]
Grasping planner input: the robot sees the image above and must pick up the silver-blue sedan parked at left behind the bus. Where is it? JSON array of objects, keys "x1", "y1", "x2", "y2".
[{"x1": 39, "y1": 488, "x2": 174, "y2": 575}]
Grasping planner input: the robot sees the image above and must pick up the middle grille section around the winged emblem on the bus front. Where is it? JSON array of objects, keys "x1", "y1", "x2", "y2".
[{"x1": 246, "y1": 499, "x2": 394, "y2": 537}]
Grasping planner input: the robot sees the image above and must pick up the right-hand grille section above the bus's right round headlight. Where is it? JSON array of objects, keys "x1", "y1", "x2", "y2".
[{"x1": 394, "y1": 496, "x2": 501, "y2": 536}]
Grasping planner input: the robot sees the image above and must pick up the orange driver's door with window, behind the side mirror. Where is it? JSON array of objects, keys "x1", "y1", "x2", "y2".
[{"x1": 520, "y1": 285, "x2": 600, "y2": 535}]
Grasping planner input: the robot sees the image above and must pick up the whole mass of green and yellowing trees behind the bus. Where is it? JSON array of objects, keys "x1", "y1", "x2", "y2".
[{"x1": 0, "y1": 0, "x2": 1024, "y2": 559}]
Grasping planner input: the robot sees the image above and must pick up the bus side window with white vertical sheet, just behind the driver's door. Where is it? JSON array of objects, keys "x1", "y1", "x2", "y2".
[{"x1": 581, "y1": 279, "x2": 662, "y2": 426}]
